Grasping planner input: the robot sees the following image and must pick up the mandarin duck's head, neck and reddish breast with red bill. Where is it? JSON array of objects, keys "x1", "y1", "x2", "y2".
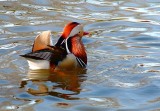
[{"x1": 55, "y1": 22, "x2": 89, "y2": 67}]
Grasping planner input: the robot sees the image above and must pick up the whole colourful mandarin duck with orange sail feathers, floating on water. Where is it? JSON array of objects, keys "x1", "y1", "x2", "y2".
[{"x1": 21, "y1": 22, "x2": 89, "y2": 70}]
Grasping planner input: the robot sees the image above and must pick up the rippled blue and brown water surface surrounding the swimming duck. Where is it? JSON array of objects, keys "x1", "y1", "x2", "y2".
[{"x1": 0, "y1": 0, "x2": 160, "y2": 111}]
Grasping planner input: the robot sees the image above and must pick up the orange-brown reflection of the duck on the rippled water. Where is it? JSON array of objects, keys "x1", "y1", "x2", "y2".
[{"x1": 20, "y1": 69, "x2": 87, "y2": 100}]
